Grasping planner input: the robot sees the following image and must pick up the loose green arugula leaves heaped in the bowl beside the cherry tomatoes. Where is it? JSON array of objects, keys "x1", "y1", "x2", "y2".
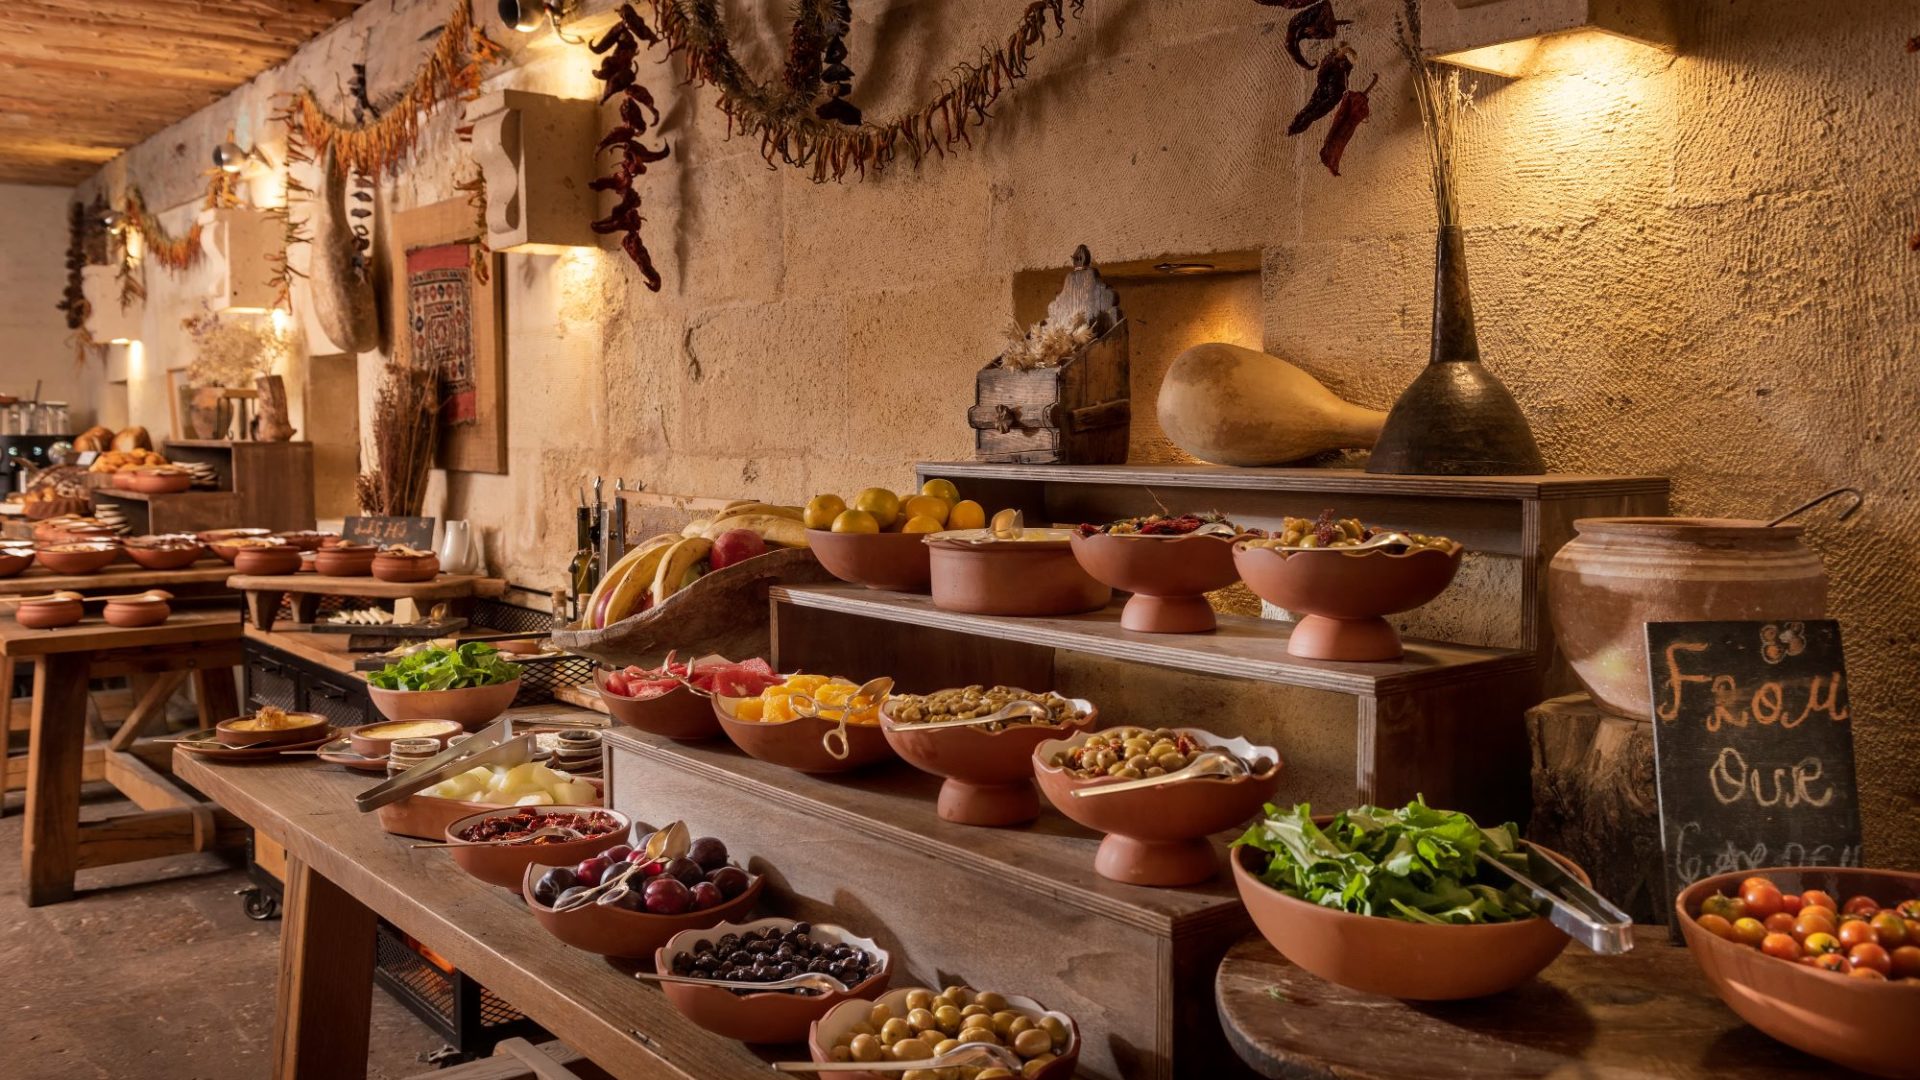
[{"x1": 1235, "y1": 799, "x2": 1540, "y2": 926}]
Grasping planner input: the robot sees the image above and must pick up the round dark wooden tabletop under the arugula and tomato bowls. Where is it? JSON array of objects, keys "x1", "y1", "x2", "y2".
[{"x1": 1213, "y1": 926, "x2": 1849, "y2": 1080}]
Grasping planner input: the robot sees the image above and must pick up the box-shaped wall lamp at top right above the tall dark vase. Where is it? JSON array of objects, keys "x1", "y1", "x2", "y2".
[{"x1": 1421, "y1": 0, "x2": 1680, "y2": 79}]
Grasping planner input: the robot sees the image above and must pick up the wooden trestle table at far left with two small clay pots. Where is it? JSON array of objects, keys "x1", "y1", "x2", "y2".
[{"x1": 0, "y1": 611, "x2": 240, "y2": 907}]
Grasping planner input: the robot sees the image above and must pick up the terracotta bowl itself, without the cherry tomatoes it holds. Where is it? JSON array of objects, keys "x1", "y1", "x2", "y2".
[{"x1": 1672, "y1": 867, "x2": 1920, "y2": 1076}]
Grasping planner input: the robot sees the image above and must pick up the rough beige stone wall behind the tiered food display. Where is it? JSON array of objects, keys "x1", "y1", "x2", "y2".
[{"x1": 71, "y1": 0, "x2": 1920, "y2": 865}]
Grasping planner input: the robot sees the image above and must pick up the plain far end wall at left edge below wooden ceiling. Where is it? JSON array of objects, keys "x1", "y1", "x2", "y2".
[{"x1": 0, "y1": 184, "x2": 102, "y2": 430}]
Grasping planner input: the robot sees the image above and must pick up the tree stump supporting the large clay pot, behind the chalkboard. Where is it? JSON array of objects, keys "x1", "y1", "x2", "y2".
[{"x1": 1526, "y1": 694, "x2": 1672, "y2": 924}]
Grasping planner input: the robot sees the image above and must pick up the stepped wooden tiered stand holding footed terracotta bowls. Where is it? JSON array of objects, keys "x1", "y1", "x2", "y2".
[{"x1": 595, "y1": 461, "x2": 1667, "y2": 1078}]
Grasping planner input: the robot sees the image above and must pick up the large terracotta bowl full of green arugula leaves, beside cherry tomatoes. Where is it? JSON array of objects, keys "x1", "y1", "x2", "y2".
[{"x1": 1229, "y1": 799, "x2": 1586, "y2": 1001}]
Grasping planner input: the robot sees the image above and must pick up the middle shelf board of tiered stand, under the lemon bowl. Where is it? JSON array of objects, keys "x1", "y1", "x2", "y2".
[{"x1": 770, "y1": 584, "x2": 1532, "y2": 698}]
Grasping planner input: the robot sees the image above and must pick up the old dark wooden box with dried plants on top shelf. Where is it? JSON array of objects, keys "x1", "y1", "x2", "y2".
[{"x1": 968, "y1": 244, "x2": 1133, "y2": 465}]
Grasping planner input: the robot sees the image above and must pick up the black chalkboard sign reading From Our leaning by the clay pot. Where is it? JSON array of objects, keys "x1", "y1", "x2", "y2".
[{"x1": 1647, "y1": 619, "x2": 1860, "y2": 907}]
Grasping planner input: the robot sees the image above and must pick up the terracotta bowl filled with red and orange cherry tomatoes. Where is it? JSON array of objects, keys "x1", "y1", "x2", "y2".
[{"x1": 1674, "y1": 867, "x2": 1920, "y2": 1078}]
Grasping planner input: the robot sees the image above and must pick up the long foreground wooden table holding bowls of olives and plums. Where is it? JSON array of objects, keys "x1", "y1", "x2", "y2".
[{"x1": 175, "y1": 751, "x2": 771, "y2": 1080}]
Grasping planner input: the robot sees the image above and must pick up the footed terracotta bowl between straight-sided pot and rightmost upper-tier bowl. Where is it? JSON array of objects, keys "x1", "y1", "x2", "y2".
[{"x1": 1073, "y1": 532, "x2": 1240, "y2": 634}]
